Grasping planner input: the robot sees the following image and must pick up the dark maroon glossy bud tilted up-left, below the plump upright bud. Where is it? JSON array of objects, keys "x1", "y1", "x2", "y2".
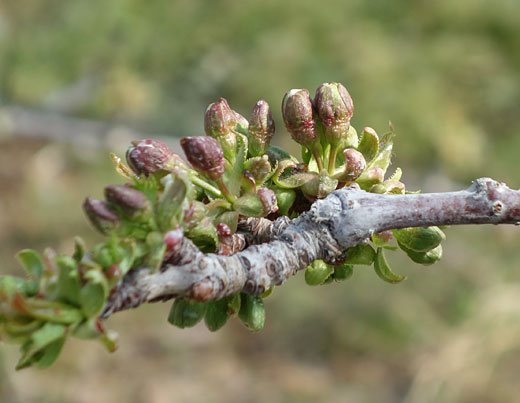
[{"x1": 181, "y1": 136, "x2": 226, "y2": 181}]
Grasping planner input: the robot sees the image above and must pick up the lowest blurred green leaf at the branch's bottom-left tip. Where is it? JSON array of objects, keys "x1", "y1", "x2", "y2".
[{"x1": 16, "y1": 323, "x2": 66, "y2": 370}]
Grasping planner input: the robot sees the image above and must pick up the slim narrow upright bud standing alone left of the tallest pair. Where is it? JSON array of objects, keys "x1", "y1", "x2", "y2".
[{"x1": 247, "y1": 99, "x2": 274, "y2": 157}]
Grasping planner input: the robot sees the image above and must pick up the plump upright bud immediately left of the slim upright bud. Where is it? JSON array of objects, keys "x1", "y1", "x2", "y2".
[{"x1": 204, "y1": 98, "x2": 239, "y2": 161}]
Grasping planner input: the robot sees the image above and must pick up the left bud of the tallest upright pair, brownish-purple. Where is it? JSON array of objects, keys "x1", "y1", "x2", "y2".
[{"x1": 282, "y1": 89, "x2": 319, "y2": 148}]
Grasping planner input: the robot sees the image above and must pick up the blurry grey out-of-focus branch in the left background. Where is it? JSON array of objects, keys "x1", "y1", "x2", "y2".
[{"x1": 0, "y1": 106, "x2": 180, "y2": 152}]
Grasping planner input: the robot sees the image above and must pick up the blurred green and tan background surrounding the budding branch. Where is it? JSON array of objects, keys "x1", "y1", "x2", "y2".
[{"x1": 0, "y1": 0, "x2": 520, "y2": 403}]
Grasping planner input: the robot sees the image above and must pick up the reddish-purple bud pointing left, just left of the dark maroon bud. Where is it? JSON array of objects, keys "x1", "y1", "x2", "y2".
[{"x1": 126, "y1": 139, "x2": 188, "y2": 176}]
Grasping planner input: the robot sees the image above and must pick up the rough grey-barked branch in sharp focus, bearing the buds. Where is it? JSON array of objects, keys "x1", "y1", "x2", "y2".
[{"x1": 99, "y1": 178, "x2": 520, "y2": 317}]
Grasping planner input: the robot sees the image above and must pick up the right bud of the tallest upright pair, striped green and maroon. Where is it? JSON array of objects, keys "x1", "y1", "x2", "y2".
[{"x1": 314, "y1": 83, "x2": 357, "y2": 146}]
